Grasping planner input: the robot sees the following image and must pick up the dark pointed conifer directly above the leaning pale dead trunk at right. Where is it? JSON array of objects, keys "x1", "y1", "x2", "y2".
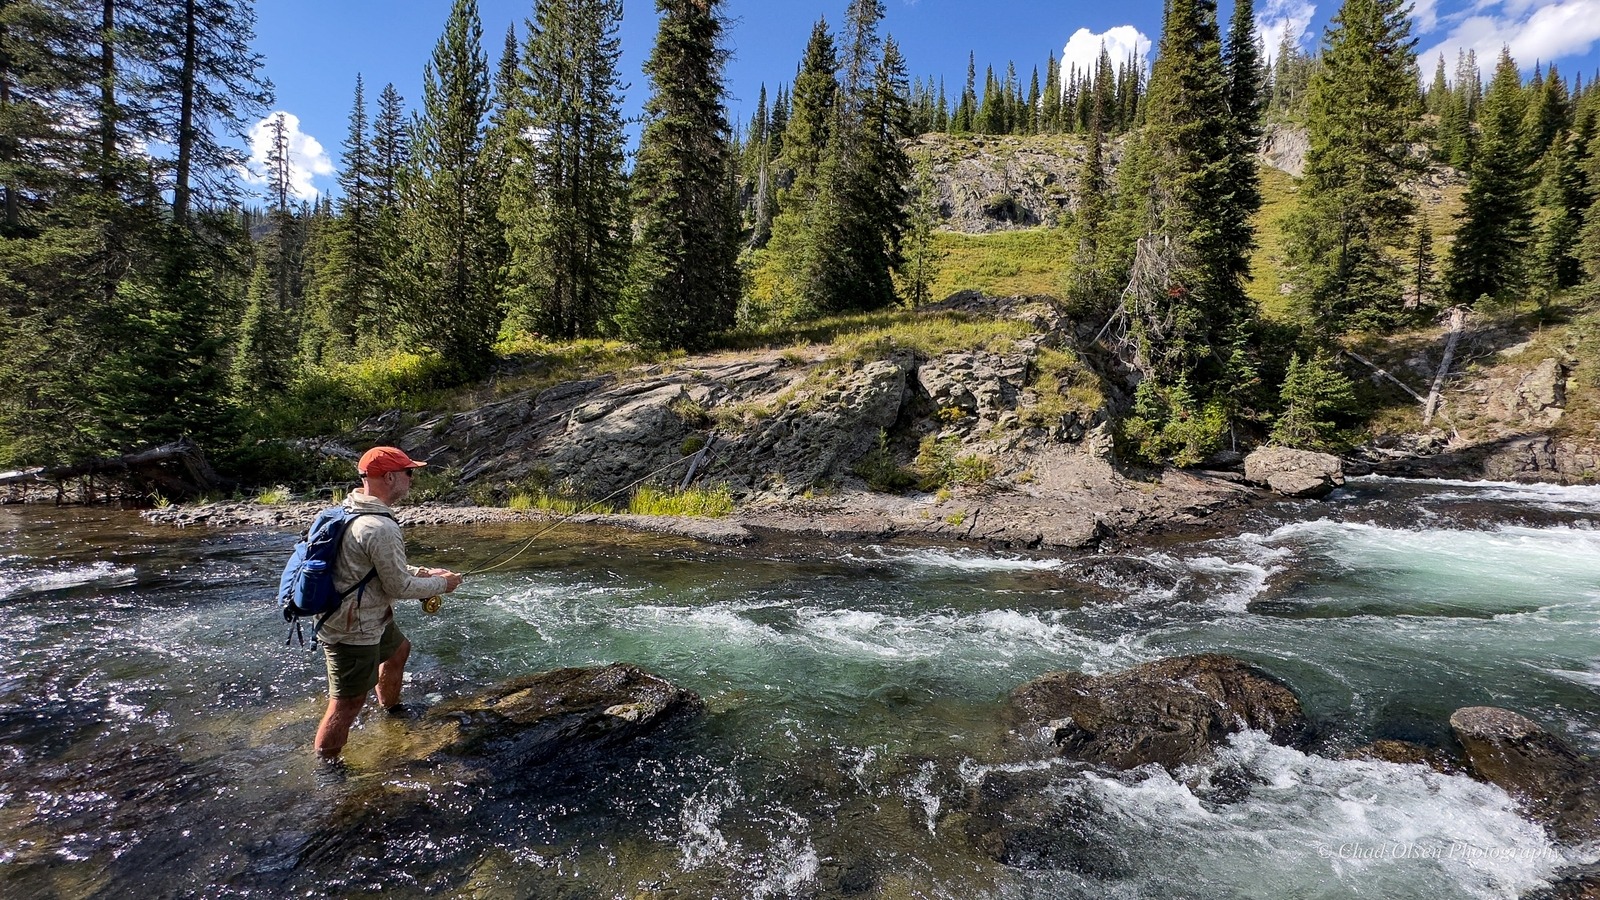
[{"x1": 1445, "y1": 51, "x2": 1533, "y2": 304}]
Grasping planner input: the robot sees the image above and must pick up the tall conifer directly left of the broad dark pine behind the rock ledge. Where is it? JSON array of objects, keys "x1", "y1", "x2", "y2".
[{"x1": 501, "y1": 0, "x2": 629, "y2": 338}]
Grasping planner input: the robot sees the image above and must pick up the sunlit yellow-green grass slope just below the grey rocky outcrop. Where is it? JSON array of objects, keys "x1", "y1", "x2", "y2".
[{"x1": 930, "y1": 227, "x2": 1070, "y2": 299}]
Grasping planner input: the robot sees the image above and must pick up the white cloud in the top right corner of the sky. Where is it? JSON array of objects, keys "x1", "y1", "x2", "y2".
[{"x1": 1421, "y1": 0, "x2": 1600, "y2": 77}]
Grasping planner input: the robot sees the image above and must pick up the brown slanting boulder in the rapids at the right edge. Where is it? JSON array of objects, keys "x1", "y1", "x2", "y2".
[{"x1": 1450, "y1": 706, "x2": 1600, "y2": 841}]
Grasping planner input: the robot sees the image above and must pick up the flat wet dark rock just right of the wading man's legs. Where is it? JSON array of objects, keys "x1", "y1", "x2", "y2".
[{"x1": 419, "y1": 665, "x2": 704, "y2": 772}]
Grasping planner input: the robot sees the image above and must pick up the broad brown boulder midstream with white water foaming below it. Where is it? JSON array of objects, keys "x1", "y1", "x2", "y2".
[{"x1": 1011, "y1": 653, "x2": 1310, "y2": 770}]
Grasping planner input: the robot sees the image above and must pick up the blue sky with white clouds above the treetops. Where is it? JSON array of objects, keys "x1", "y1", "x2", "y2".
[{"x1": 243, "y1": 0, "x2": 1600, "y2": 197}]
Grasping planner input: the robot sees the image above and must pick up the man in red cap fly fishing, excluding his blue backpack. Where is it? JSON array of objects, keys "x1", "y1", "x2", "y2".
[{"x1": 315, "y1": 447, "x2": 462, "y2": 762}]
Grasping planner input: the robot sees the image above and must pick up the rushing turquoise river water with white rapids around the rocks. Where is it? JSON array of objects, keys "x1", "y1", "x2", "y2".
[{"x1": 0, "y1": 480, "x2": 1600, "y2": 898}]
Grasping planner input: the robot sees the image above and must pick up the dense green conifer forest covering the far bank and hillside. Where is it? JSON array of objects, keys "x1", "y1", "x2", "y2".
[{"x1": 0, "y1": 0, "x2": 1600, "y2": 482}]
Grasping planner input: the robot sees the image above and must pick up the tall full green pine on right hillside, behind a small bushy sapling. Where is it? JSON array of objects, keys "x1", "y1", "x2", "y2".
[{"x1": 1286, "y1": 0, "x2": 1416, "y2": 328}]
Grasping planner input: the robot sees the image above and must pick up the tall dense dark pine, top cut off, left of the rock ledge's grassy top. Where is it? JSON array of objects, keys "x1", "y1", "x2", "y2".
[{"x1": 618, "y1": 0, "x2": 739, "y2": 349}]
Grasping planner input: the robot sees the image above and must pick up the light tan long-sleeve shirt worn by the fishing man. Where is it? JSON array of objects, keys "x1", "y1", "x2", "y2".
[{"x1": 317, "y1": 490, "x2": 448, "y2": 644}]
